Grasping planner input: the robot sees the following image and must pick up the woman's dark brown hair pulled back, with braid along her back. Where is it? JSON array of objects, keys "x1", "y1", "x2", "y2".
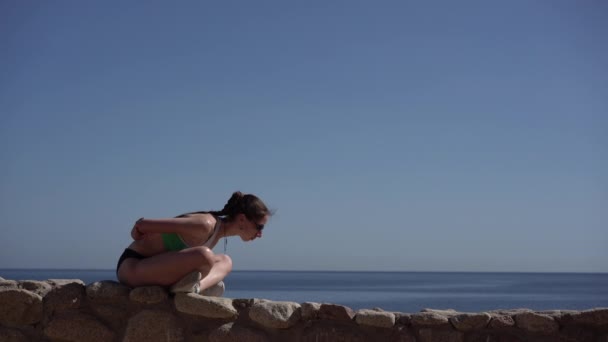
[{"x1": 177, "y1": 191, "x2": 272, "y2": 221}]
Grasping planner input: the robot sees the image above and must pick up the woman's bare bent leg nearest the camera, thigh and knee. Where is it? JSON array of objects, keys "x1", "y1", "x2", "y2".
[{"x1": 118, "y1": 247, "x2": 232, "y2": 290}]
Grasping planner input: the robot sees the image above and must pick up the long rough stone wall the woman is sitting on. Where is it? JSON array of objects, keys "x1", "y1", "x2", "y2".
[{"x1": 0, "y1": 278, "x2": 608, "y2": 342}]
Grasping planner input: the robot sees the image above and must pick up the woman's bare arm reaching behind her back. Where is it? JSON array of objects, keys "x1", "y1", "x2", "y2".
[{"x1": 131, "y1": 215, "x2": 210, "y2": 240}]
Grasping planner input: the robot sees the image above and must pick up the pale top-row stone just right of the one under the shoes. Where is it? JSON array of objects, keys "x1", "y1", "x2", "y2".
[{"x1": 249, "y1": 302, "x2": 302, "y2": 329}]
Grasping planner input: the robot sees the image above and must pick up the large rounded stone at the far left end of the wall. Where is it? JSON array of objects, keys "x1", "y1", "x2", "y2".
[{"x1": 0, "y1": 288, "x2": 42, "y2": 325}]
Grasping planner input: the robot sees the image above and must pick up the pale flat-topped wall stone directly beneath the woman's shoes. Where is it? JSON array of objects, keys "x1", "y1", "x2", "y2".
[{"x1": 174, "y1": 293, "x2": 238, "y2": 319}]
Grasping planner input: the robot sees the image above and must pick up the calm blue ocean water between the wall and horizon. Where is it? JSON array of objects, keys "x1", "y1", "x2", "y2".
[{"x1": 0, "y1": 269, "x2": 608, "y2": 312}]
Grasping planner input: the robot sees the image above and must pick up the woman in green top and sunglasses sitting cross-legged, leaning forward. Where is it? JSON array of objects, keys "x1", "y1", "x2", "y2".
[{"x1": 116, "y1": 191, "x2": 271, "y2": 296}]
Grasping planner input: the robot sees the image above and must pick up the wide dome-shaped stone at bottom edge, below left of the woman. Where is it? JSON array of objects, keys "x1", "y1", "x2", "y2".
[{"x1": 44, "y1": 313, "x2": 115, "y2": 342}]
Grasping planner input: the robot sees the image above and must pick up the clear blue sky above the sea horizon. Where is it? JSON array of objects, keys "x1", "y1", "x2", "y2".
[{"x1": 0, "y1": 0, "x2": 608, "y2": 272}]
